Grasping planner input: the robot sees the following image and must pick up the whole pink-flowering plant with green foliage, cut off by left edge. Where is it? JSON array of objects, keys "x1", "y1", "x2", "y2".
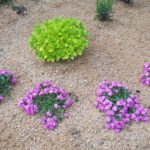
[{"x1": 0, "y1": 69, "x2": 17, "y2": 102}]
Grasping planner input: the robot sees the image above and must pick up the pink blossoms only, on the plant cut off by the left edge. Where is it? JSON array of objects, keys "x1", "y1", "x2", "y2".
[{"x1": 0, "y1": 69, "x2": 17, "y2": 102}]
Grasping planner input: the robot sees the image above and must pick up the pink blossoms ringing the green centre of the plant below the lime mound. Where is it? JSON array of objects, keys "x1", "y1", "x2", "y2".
[{"x1": 18, "y1": 81, "x2": 73, "y2": 130}]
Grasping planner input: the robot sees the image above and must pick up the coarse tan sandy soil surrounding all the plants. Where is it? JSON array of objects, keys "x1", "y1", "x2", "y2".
[{"x1": 0, "y1": 0, "x2": 150, "y2": 150}]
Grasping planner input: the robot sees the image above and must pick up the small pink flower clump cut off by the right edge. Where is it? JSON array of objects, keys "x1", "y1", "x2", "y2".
[{"x1": 140, "y1": 62, "x2": 150, "y2": 86}]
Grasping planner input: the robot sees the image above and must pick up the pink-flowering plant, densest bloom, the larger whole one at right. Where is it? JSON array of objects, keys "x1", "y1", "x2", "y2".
[{"x1": 95, "y1": 81, "x2": 148, "y2": 132}]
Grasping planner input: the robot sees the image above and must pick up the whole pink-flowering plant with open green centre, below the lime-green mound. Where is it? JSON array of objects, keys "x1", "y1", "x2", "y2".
[{"x1": 18, "y1": 81, "x2": 73, "y2": 130}]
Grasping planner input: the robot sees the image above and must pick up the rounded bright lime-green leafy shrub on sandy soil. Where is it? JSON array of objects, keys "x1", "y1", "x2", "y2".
[{"x1": 29, "y1": 18, "x2": 88, "y2": 62}]
